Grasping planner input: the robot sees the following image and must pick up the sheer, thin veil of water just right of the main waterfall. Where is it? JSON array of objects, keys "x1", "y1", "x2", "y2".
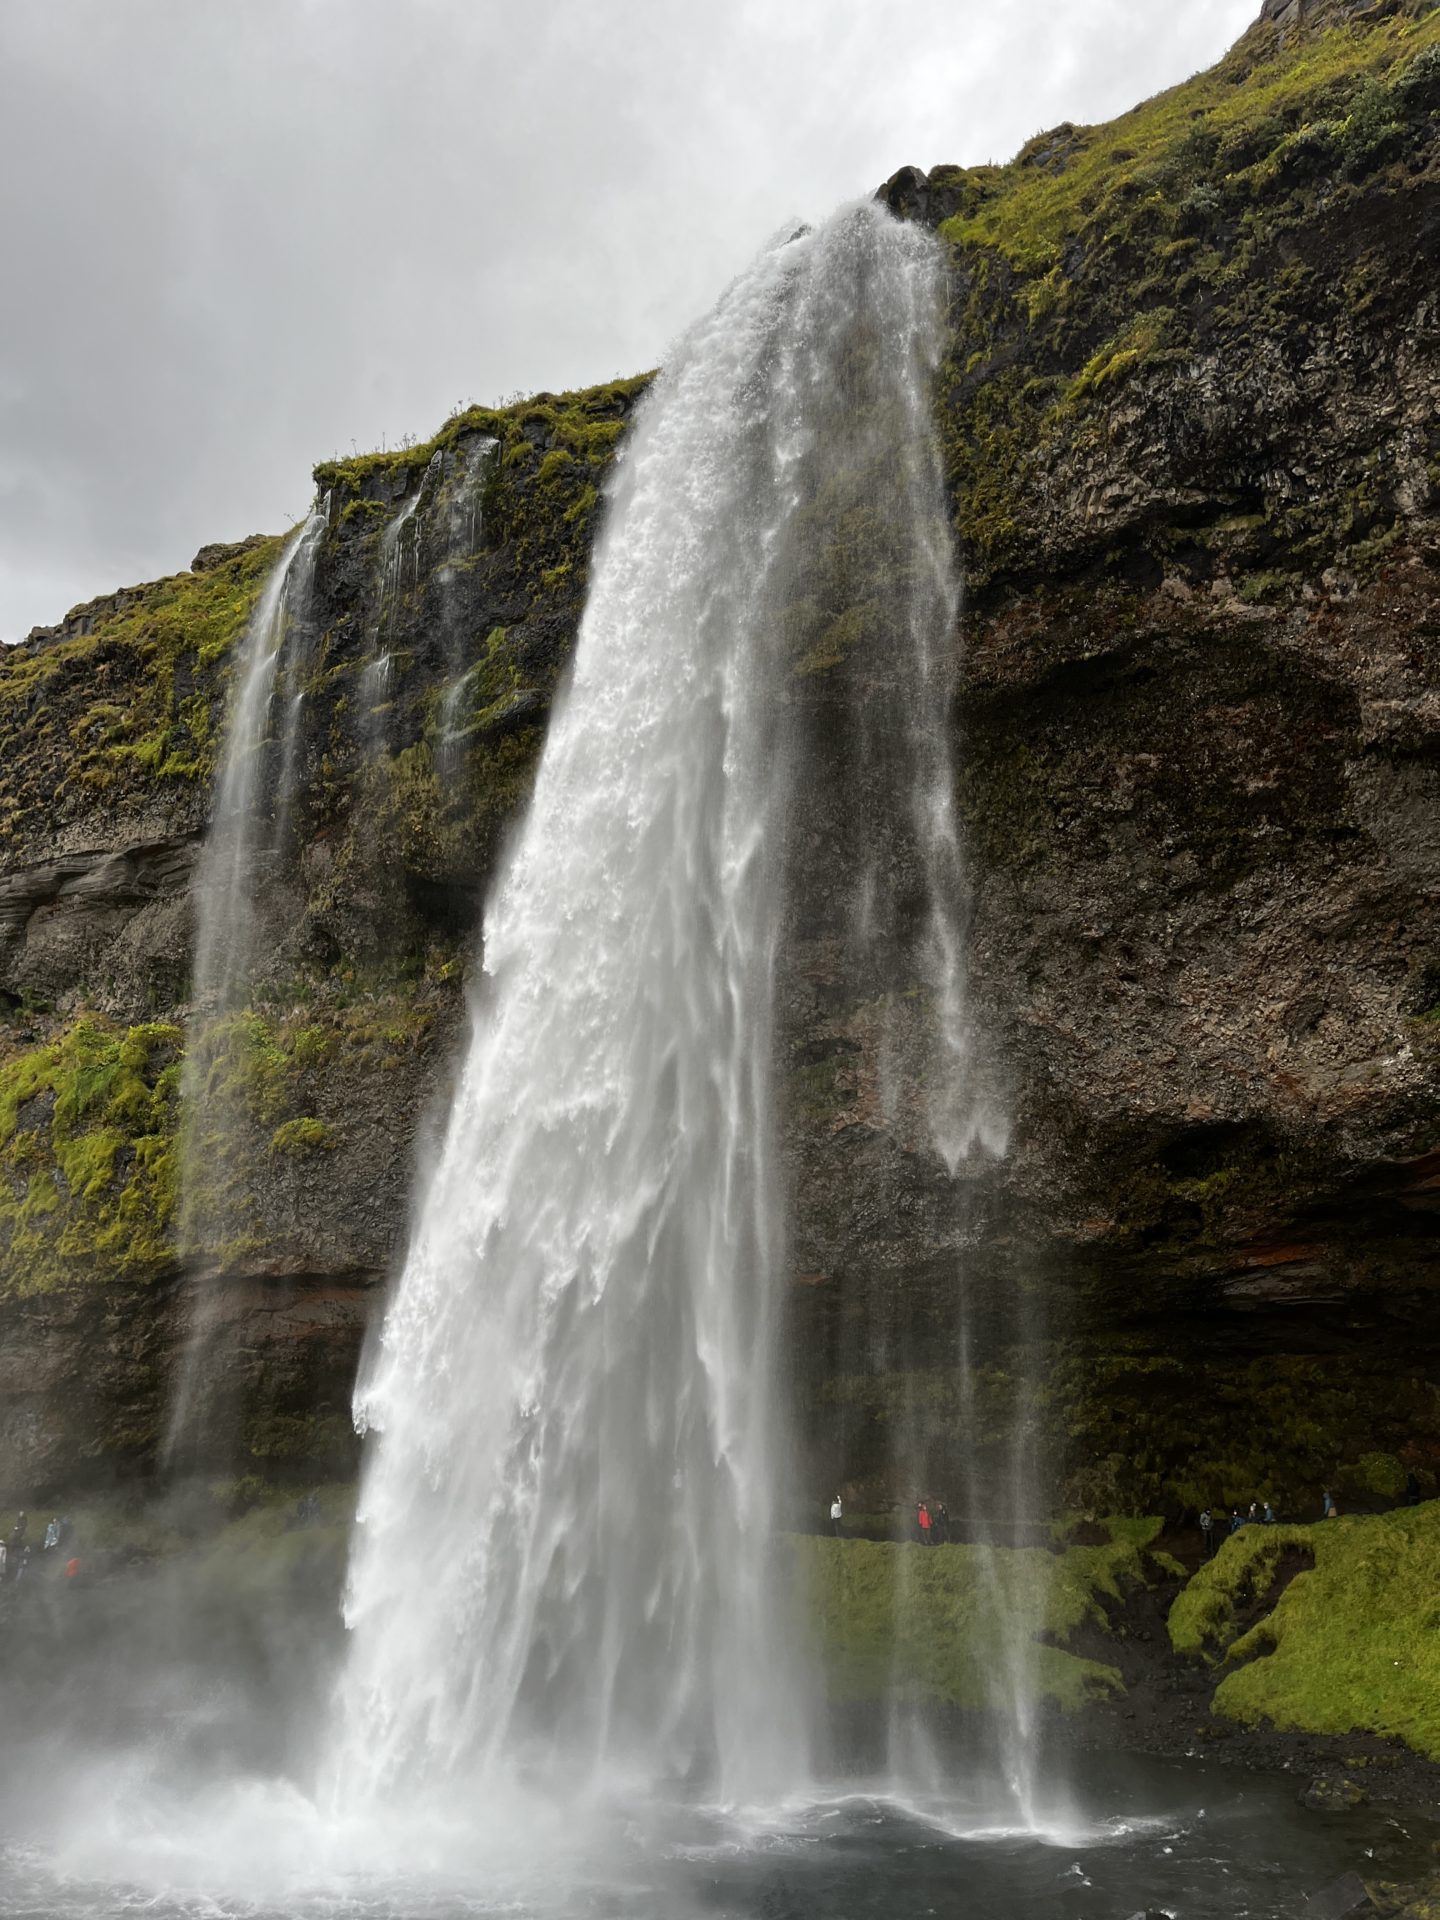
[{"x1": 748, "y1": 198, "x2": 1043, "y2": 1826}]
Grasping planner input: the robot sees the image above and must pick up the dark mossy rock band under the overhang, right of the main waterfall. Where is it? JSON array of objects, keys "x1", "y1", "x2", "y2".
[{"x1": 804, "y1": 1351, "x2": 1440, "y2": 1526}]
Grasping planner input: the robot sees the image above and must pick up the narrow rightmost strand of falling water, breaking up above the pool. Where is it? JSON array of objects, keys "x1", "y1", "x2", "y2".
[{"x1": 806, "y1": 240, "x2": 1043, "y2": 1828}]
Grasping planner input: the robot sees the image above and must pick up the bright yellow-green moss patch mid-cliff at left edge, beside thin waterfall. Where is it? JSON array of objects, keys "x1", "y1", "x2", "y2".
[{"x1": 0, "y1": 1018, "x2": 180, "y2": 1296}]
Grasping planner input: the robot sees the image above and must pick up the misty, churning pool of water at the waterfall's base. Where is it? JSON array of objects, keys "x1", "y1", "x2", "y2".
[{"x1": 0, "y1": 1763, "x2": 1440, "y2": 1920}]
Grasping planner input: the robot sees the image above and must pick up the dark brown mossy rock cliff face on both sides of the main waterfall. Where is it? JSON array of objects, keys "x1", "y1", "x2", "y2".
[{"x1": 0, "y1": 6, "x2": 1440, "y2": 1505}]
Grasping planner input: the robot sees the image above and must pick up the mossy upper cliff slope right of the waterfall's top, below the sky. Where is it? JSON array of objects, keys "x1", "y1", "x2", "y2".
[{"x1": 881, "y1": 0, "x2": 1440, "y2": 591}]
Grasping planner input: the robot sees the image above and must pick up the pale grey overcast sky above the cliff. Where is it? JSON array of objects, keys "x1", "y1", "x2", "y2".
[{"x1": 0, "y1": 0, "x2": 1260, "y2": 637}]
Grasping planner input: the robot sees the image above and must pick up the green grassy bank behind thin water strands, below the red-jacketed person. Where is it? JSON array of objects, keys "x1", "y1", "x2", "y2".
[{"x1": 789, "y1": 1534, "x2": 1144, "y2": 1711}]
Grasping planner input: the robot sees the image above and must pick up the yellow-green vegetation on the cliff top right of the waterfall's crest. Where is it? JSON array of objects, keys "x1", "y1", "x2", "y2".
[{"x1": 929, "y1": 0, "x2": 1440, "y2": 591}]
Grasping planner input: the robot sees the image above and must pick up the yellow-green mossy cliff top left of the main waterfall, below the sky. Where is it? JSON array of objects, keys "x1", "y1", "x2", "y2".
[{"x1": 0, "y1": 374, "x2": 651, "y2": 852}]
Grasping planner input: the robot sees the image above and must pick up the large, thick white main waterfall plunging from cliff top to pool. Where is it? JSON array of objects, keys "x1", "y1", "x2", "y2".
[{"x1": 334, "y1": 207, "x2": 975, "y2": 1799}]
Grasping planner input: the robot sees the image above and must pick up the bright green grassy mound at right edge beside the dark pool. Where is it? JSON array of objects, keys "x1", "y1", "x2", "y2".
[{"x1": 1169, "y1": 1501, "x2": 1440, "y2": 1759}]
